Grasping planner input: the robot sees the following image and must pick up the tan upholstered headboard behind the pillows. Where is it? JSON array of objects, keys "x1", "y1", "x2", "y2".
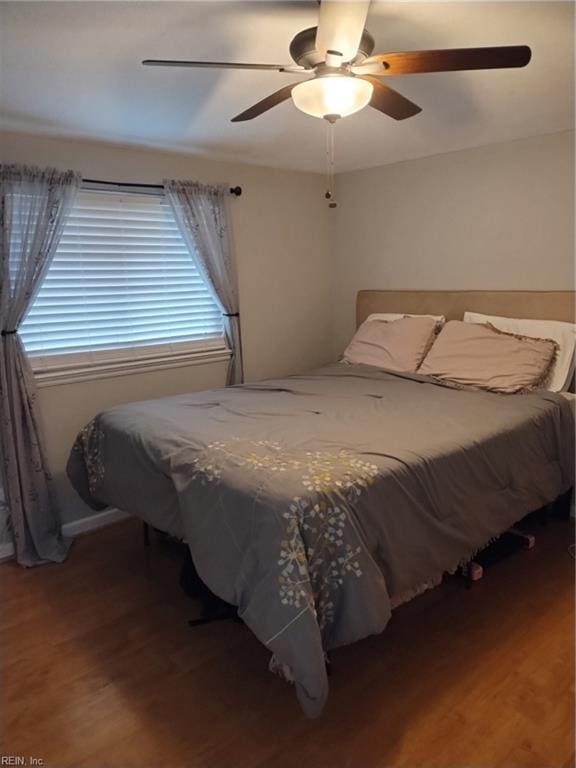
[{"x1": 356, "y1": 291, "x2": 576, "y2": 325}]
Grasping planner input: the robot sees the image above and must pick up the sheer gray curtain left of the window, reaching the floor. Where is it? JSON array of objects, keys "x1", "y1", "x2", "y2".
[{"x1": 0, "y1": 165, "x2": 80, "y2": 566}]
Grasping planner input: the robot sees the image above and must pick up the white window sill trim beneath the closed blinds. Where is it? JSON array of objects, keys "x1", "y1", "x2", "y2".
[{"x1": 29, "y1": 346, "x2": 231, "y2": 387}]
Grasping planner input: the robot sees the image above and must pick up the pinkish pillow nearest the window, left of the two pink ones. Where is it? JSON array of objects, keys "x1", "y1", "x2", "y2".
[{"x1": 343, "y1": 317, "x2": 436, "y2": 373}]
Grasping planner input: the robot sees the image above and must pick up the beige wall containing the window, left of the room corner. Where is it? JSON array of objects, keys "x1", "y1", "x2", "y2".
[{"x1": 0, "y1": 134, "x2": 332, "y2": 521}]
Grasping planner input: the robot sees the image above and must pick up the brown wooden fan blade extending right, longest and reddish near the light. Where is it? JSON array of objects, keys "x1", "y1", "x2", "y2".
[{"x1": 353, "y1": 45, "x2": 532, "y2": 76}]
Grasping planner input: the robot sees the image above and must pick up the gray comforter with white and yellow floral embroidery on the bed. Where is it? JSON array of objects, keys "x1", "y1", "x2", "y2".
[{"x1": 68, "y1": 364, "x2": 574, "y2": 716}]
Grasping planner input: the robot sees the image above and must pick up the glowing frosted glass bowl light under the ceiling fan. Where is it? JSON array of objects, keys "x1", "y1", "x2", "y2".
[{"x1": 292, "y1": 75, "x2": 374, "y2": 119}]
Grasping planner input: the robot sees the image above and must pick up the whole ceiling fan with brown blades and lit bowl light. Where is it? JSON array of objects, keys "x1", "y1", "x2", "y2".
[{"x1": 142, "y1": 0, "x2": 532, "y2": 123}]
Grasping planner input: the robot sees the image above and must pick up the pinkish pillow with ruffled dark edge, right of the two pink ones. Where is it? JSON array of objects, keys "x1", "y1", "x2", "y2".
[{"x1": 418, "y1": 320, "x2": 558, "y2": 394}]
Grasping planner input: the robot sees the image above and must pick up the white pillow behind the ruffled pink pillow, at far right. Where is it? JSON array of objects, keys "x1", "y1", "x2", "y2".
[{"x1": 464, "y1": 312, "x2": 576, "y2": 392}]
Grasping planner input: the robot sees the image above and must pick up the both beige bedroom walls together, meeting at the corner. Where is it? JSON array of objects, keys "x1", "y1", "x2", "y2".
[{"x1": 0, "y1": 133, "x2": 574, "y2": 536}]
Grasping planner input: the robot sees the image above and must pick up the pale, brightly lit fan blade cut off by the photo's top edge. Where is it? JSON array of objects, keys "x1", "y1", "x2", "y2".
[{"x1": 316, "y1": 0, "x2": 370, "y2": 62}]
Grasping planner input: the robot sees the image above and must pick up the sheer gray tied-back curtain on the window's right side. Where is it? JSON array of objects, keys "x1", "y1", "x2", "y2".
[{"x1": 164, "y1": 180, "x2": 244, "y2": 384}]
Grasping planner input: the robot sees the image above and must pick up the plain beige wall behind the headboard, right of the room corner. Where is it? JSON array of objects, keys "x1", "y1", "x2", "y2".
[{"x1": 333, "y1": 132, "x2": 574, "y2": 354}]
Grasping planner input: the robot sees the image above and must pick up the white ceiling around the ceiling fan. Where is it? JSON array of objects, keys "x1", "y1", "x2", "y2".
[{"x1": 0, "y1": 0, "x2": 574, "y2": 171}]
